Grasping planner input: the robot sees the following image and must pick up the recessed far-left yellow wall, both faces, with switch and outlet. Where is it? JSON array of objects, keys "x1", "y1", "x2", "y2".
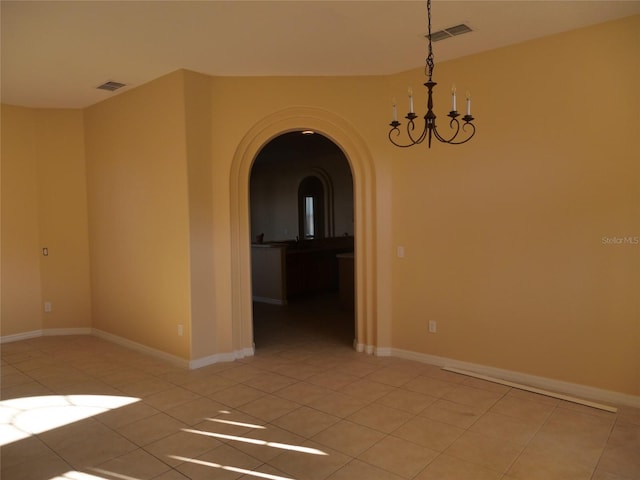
[{"x1": 2, "y1": 105, "x2": 91, "y2": 336}]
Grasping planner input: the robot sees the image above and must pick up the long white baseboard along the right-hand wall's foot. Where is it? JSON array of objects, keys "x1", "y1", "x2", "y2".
[{"x1": 388, "y1": 348, "x2": 640, "y2": 408}]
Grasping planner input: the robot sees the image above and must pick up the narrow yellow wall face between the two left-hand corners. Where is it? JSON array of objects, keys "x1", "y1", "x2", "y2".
[{"x1": 36, "y1": 109, "x2": 92, "y2": 329}]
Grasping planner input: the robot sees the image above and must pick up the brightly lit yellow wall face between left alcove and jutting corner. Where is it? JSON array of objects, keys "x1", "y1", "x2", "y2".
[{"x1": 85, "y1": 71, "x2": 193, "y2": 359}]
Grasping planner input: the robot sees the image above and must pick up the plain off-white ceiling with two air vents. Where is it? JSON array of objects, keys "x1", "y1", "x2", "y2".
[{"x1": 0, "y1": 0, "x2": 640, "y2": 108}]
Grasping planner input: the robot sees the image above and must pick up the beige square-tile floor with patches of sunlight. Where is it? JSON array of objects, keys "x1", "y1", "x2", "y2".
[{"x1": 0, "y1": 292, "x2": 640, "y2": 480}]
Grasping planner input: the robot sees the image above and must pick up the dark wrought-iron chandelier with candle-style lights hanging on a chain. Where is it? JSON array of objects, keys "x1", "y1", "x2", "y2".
[{"x1": 389, "y1": 0, "x2": 476, "y2": 148}]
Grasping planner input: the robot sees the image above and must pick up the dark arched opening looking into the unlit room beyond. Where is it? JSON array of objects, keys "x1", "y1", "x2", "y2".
[{"x1": 249, "y1": 131, "x2": 355, "y2": 349}]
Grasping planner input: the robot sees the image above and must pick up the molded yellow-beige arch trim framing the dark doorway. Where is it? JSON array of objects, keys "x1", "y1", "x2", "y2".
[{"x1": 229, "y1": 107, "x2": 391, "y2": 354}]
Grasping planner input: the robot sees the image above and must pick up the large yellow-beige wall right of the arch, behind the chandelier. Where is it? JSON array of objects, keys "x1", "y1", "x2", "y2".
[{"x1": 392, "y1": 17, "x2": 640, "y2": 396}]
